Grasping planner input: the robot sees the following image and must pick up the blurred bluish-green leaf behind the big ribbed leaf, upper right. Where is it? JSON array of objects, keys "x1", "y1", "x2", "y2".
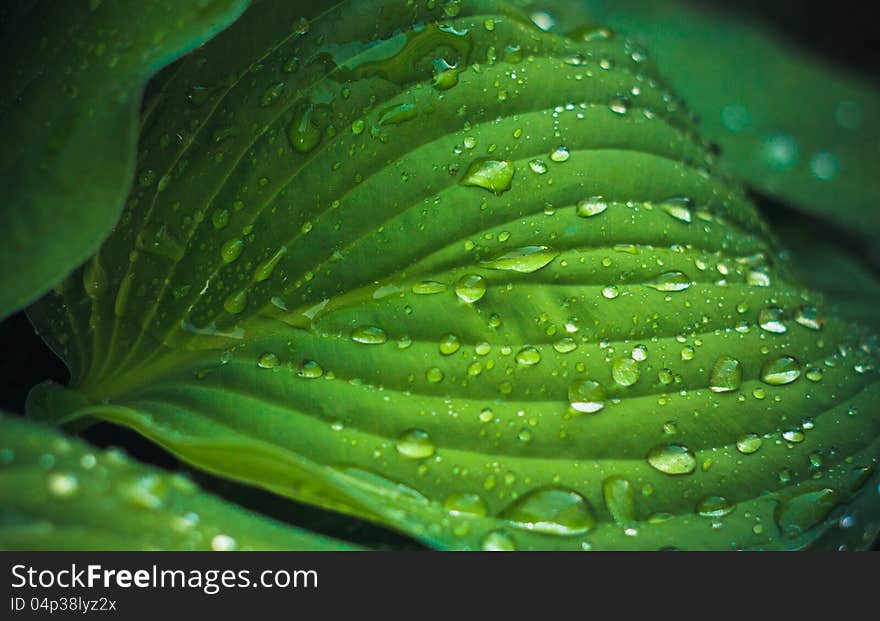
[{"x1": 540, "y1": 0, "x2": 880, "y2": 254}]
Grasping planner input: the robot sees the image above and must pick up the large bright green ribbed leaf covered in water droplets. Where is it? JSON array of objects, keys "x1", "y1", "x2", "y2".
[{"x1": 28, "y1": 0, "x2": 880, "y2": 550}]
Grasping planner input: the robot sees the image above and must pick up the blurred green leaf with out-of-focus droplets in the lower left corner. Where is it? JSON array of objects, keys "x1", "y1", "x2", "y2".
[{"x1": 0, "y1": 414, "x2": 354, "y2": 550}]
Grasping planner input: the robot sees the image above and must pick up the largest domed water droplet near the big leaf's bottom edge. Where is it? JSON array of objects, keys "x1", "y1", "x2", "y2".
[{"x1": 499, "y1": 487, "x2": 596, "y2": 535}]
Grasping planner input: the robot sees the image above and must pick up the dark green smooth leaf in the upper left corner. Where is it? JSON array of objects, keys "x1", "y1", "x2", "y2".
[{"x1": 0, "y1": 0, "x2": 247, "y2": 318}]
